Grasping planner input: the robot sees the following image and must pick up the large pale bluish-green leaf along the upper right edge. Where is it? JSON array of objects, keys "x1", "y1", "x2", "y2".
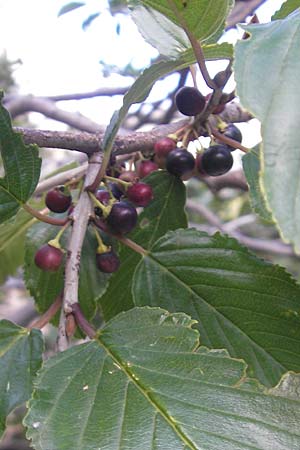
[{"x1": 235, "y1": 10, "x2": 300, "y2": 252}]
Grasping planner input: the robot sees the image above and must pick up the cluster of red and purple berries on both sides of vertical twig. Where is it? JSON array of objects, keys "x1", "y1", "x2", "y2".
[{"x1": 34, "y1": 158, "x2": 158, "y2": 273}]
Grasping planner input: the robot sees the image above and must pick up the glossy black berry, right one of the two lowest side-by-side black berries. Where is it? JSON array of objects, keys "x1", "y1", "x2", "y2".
[{"x1": 201, "y1": 144, "x2": 233, "y2": 177}]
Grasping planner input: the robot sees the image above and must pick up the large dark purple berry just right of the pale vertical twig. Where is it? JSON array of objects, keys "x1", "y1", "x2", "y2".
[{"x1": 106, "y1": 201, "x2": 138, "y2": 234}]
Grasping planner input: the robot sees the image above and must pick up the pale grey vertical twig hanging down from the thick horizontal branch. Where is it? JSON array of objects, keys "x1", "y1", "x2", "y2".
[{"x1": 57, "y1": 152, "x2": 102, "y2": 351}]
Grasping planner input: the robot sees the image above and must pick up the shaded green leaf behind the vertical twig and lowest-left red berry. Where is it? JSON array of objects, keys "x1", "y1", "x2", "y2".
[{"x1": 24, "y1": 222, "x2": 109, "y2": 320}]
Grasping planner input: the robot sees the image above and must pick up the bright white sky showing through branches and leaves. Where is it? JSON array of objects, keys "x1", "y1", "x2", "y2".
[{"x1": 0, "y1": 0, "x2": 283, "y2": 140}]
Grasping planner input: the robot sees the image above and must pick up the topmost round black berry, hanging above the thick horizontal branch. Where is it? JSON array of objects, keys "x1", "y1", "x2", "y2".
[{"x1": 175, "y1": 86, "x2": 205, "y2": 116}]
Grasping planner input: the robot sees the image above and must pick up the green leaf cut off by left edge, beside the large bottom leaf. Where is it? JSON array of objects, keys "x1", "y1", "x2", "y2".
[{"x1": 0, "y1": 320, "x2": 43, "y2": 438}]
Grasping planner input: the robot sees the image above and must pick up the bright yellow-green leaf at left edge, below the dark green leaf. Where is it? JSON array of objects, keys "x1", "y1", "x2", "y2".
[{"x1": 0, "y1": 210, "x2": 36, "y2": 284}]
